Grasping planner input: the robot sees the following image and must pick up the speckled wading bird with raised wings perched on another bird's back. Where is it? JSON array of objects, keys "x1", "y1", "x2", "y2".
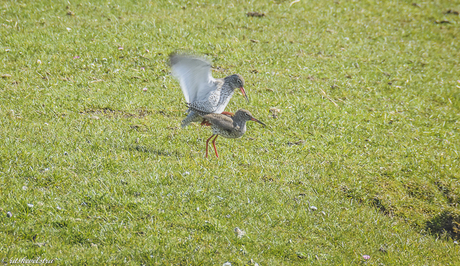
[{"x1": 169, "y1": 53, "x2": 249, "y2": 128}]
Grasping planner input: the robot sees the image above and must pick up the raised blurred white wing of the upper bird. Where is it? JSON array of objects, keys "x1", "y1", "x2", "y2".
[{"x1": 169, "y1": 54, "x2": 217, "y2": 103}]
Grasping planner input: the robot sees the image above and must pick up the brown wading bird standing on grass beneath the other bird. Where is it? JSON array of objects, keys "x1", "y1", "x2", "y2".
[{"x1": 188, "y1": 105, "x2": 266, "y2": 158}]
